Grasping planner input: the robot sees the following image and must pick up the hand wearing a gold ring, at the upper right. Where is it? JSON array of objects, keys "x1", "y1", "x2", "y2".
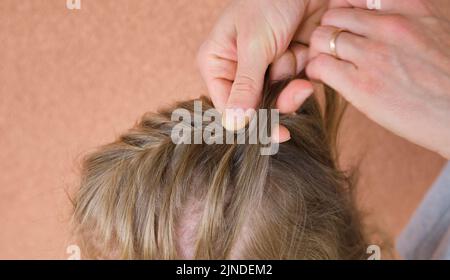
[{"x1": 307, "y1": 0, "x2": 450, "y2": 159}]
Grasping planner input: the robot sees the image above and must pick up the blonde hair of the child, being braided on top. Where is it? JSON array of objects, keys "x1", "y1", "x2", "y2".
[{"x1": 73, "y1": 74, "x2": 366, "y2": 259}]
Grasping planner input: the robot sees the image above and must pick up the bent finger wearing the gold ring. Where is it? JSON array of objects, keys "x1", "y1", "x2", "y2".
[{"x1": 310, "y1": 26, "x2": 369, "y2": 65}]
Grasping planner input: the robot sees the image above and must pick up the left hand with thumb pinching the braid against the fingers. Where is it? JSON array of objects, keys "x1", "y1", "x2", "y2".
[{"x1": 198, "y1": 0, "x2": 328, "y2": 141}]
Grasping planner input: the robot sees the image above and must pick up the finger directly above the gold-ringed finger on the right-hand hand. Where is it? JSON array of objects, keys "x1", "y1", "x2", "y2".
[{"x1": 321, "y1": 8, "x2": 384, "y2": 39}]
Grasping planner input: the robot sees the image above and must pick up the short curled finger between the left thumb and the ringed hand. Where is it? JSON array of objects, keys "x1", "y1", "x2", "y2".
[{"x1": 270, "y1": 44, "x2": 309, "y2": 81}]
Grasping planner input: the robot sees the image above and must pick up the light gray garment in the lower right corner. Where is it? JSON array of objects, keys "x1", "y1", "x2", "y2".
[{"x1": 397, "y1": 162, "x2": 450, "y2": 260}]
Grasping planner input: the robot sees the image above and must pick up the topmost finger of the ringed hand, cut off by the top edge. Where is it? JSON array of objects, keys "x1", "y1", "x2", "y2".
[{"x1": 330, "y1": 0, "x2": 426, "y2": 15}]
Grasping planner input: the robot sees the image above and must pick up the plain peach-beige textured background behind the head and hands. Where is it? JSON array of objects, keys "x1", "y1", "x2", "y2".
[{"x1": 0, "y1": 0, "x2": 444, "y2": 259}]
